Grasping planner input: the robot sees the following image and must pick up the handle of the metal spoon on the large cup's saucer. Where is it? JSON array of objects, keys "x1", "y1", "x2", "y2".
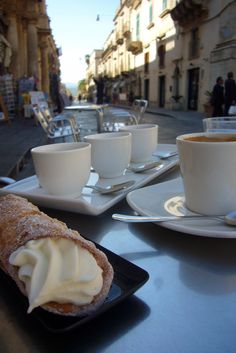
[{"x1": 112, "y1": 213, "x2": 222, "y2": 223}]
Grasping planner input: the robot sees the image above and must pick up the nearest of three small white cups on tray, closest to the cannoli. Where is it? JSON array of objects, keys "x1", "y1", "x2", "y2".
[{"x1": 31, "y1": 142, "x2": 91, "y2": 196}]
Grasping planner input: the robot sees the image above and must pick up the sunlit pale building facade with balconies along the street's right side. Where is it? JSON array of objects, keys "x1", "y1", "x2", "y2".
[{"x1": 85, "y1": 0, "x2": 236, "y2": 111}]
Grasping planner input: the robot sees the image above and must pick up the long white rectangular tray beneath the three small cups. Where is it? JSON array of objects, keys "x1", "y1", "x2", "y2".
[{"x1": 0, "y1": 144, "x2": 178, "y2": 216}]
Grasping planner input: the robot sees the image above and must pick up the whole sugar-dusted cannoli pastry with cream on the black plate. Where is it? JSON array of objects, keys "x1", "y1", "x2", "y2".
[{"x1": 0, "y1": 194, "x2": 113, "y2": 316}]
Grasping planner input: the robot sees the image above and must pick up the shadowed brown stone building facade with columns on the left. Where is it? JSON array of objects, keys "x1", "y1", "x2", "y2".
[{"x1": 0, "y1": 0, "x2": 60, "y2": 114}]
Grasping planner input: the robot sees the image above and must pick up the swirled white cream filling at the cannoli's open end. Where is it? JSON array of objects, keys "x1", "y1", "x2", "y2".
[{"x1": 9, "y1": 238, "x2": 103, "y2": 313}]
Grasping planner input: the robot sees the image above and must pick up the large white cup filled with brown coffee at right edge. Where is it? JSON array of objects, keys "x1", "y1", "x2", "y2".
[{"x1": 176, "y1": 132, "x2": 236, "y2": 215}]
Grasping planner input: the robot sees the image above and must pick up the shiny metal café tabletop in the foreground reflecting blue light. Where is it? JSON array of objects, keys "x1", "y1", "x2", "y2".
[{"x1": 0, "y1": 169, "x2": 236, "y2": 353}]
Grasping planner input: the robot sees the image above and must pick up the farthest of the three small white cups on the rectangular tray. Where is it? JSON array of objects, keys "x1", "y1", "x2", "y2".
[{"x1": 120, "y1": 124, "x2": 158, "y2": 163}]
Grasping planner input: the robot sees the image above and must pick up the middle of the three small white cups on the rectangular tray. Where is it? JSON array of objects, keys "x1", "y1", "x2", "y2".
[{"x1": 84, "y1": 132, "x2": 131, "y2": 178}]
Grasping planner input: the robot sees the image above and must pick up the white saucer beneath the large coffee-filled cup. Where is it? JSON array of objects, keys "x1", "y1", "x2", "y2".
[{"x1": 126, "y1": 178, "x2": 236, "y2": 238}]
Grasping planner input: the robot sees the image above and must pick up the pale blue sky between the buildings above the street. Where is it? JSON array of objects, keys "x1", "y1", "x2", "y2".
[{"x1": 46, "y1": 0, "x2": 120, "y2": 83}]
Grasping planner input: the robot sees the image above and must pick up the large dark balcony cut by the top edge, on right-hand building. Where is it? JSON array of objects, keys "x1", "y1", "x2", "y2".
[{"x1": 170, "y1": 0, "x2": 208, "y2": 27}]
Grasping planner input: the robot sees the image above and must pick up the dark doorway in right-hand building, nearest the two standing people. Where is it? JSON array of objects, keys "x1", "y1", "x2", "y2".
[{"x1": 188, "y1": 68, "x2": 199, "y2": 110}]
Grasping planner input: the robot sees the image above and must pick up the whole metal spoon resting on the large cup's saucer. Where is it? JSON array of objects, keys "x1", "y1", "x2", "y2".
[{"x1": 112, "y1": 211, "x2": 236, "y2": 226}]
